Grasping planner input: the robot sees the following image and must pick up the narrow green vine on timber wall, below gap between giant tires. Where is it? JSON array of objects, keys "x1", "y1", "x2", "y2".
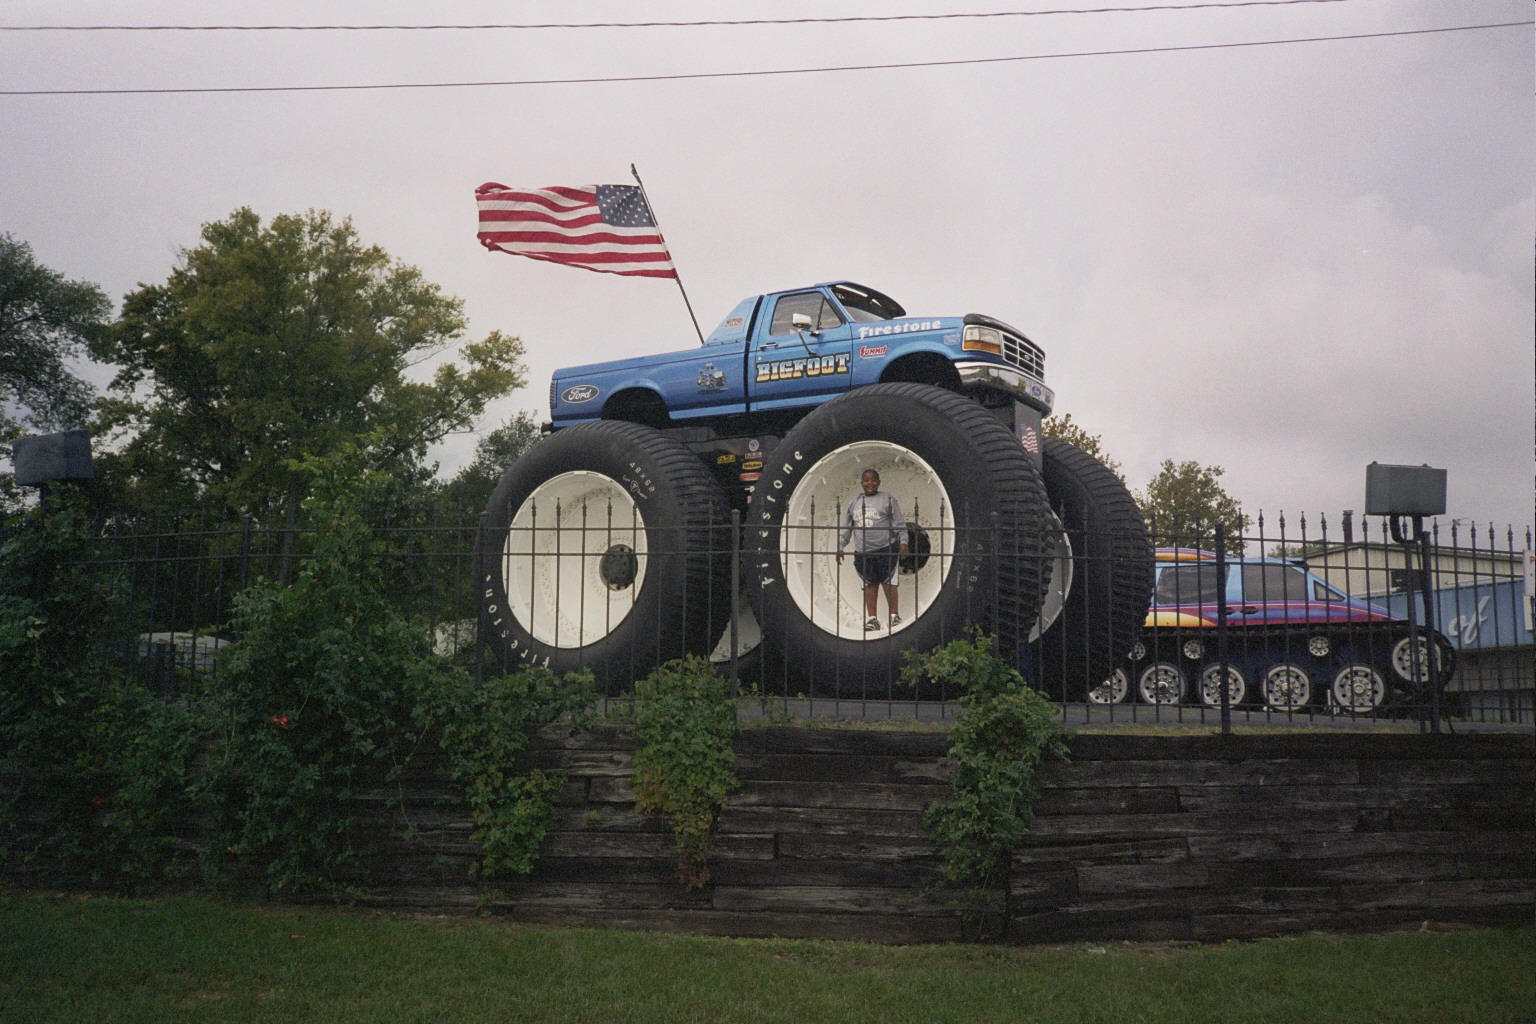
[{"x1": 625, "y1": 656, "x2": 740, "y2": 889}]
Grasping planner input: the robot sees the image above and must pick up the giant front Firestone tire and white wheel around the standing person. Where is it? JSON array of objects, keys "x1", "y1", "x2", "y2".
[{"x1": 743, "y1": 384, "x2": 1049, "y2": 697}]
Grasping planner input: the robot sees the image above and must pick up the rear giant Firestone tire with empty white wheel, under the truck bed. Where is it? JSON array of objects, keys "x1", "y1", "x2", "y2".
[{"x1": 476, "y1": 421, "x2": 730, "y2": 692}]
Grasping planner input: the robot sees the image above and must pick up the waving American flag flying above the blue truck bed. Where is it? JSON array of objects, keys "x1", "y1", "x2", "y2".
[{"x1": 475, "y1": 181, "x2": 677, "y2": 278}]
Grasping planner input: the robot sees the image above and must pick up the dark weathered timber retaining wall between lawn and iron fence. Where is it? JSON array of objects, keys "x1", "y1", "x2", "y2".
[{"x1": 351, "y1": 726, "x2": 1536, "y2": 941}]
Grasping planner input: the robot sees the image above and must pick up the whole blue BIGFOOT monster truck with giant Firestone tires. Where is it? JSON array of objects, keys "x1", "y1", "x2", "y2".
[{"x1": 476, "y1": 281, "x2": 1152, "y2": 699}]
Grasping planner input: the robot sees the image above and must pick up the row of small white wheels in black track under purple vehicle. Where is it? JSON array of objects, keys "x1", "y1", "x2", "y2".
[{"x1": 1089, "y1": 633, "x2": 1455, "y2": 714}]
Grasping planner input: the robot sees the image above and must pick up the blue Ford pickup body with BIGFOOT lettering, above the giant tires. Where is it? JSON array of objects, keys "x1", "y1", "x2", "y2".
[{"x1": 550, "y1": 281, "x2": 1054, "y2": 436}]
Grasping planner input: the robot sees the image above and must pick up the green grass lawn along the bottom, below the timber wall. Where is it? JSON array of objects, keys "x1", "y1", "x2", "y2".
[{"x1": 0, "y1": 895, "x2": 1536, "y2": 1024}]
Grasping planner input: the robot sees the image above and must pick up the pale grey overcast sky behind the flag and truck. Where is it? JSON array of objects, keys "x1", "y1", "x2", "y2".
[{"x1": 0, "y1": 0, "x2": 1536, "y2": 540}]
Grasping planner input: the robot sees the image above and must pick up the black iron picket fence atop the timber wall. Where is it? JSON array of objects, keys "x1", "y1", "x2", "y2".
[{"x1": 48, "y1": 508, "x2": 1536, "y2": 728}]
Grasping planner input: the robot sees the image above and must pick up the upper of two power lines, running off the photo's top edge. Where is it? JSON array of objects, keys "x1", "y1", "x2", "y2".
[{"x1": 0, "y1": 0, "x2": 1358, "y2": 32}]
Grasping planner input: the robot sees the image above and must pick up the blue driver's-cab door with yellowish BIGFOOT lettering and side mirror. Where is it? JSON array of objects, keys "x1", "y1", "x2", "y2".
[{"x1": 748, "y1": 290, "x2": 852, "y2": 410}]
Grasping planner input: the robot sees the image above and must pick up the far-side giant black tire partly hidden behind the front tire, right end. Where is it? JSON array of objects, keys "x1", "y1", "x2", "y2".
[{"x1": 1035, "y1": 438, "x2": 1152, "y2": 700}]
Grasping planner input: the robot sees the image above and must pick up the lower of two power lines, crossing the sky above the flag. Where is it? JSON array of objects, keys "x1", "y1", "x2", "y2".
[{"x1": 0, "y1": 21, "x2": 1533, "y2": 97}]
